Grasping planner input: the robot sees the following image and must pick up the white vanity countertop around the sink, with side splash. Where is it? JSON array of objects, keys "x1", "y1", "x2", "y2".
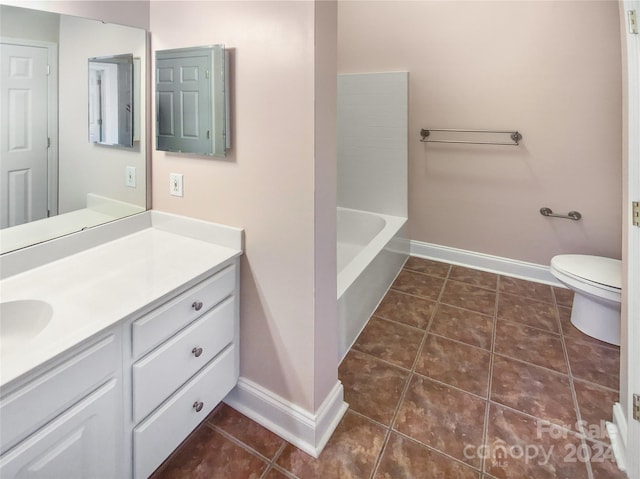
[{"x1": 0, "y1": 212, "x2": 242, "y2": 385}]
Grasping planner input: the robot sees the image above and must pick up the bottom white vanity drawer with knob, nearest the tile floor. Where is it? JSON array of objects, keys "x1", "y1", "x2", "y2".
[{"x1": 133, "y1": 345, "x2": 238, "y2": 479}]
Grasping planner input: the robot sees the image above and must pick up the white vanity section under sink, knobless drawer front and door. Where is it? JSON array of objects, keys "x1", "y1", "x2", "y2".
[{"x1": 0, "y1": 329, "x2": 127, "y2": 479}]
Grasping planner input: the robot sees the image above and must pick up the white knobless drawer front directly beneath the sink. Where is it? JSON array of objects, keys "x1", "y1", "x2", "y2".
[{"x1": 0, "y1": 334, "x2": 122, "y2": 453}]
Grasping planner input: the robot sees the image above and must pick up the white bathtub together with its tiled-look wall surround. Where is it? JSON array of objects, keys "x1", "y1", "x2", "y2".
[{"x1": 337, "y1": 72, "x2": 409, "y2": 360}]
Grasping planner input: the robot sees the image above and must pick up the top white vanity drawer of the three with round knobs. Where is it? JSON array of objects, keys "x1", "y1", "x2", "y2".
[{"x1": 132, "y1": 264, "x2": 236, "y2": 359}]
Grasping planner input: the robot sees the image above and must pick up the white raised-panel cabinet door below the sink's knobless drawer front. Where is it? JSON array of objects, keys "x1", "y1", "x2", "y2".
[{"x1": 0, "y1": 379, "x2": 125, "y2": 479}]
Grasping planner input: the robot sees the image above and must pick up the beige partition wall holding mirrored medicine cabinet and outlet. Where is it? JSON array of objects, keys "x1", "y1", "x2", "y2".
[{"x1": 151, "y1": 1, "x2": 337, "y2": 411}]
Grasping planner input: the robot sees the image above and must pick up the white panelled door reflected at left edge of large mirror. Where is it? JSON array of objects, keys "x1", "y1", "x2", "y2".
[{"x1": 0, "y1": 43, "x2": 48, "y2": 228}]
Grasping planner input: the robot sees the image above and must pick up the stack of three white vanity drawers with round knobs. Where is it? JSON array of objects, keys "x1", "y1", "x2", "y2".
[{"x1": 131, "y1": 260, "x2": 239, "y2": 479}]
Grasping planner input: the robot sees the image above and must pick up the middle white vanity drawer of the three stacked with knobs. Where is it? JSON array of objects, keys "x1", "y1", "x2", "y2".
[{"x1": 133, "y1": 296, "x2": 235, "y2": 422}]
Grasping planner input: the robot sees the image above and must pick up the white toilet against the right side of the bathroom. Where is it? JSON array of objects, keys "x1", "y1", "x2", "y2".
[{"x1": 551, "y1": 254, "x2": 622, "y2": 346}]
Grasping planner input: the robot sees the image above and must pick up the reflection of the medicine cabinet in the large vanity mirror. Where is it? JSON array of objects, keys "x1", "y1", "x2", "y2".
[{"x1": 89, "y1": 54, "x2": 133, "y2": 148}]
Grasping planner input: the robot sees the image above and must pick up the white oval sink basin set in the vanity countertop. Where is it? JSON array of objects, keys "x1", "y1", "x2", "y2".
[{"x1": 0, "y1": 300, "x2": 53, "y2": 349}]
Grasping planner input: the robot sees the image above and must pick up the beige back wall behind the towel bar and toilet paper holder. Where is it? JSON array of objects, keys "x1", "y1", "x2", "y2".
[{"x1": 338, "y1": 0, "x2": 622, "y2": 265}]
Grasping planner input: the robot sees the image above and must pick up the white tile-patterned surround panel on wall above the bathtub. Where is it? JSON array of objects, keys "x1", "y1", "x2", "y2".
[{"x1": 337, "y1": 72, "x2": 409, "y2": 217}]
